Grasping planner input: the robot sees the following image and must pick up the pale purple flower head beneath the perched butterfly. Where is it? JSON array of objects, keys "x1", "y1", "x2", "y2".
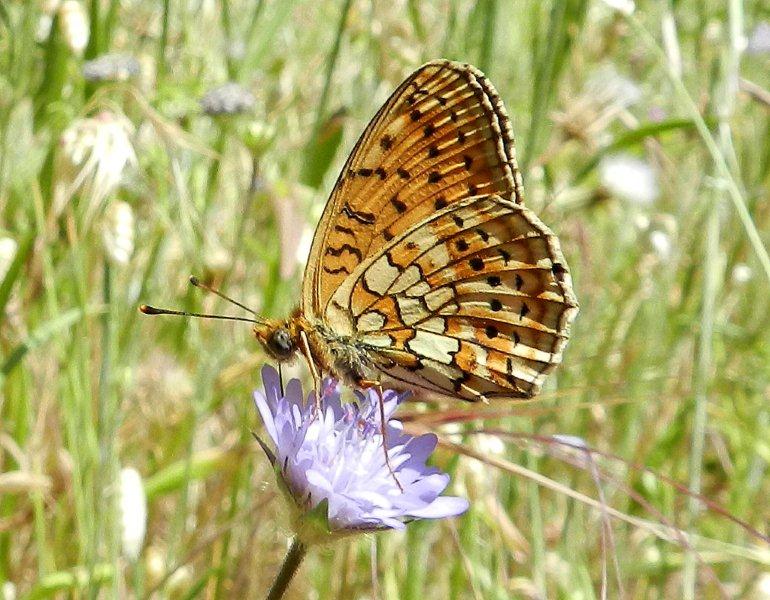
[{"x1": 254, "y1": 366, "x2": 468, "y2": 537}]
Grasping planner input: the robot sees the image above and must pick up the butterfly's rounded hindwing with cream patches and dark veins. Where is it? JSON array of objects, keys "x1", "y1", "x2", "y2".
[{"x1": 326, "y1": 196, "x2": 577, "y2": 400}]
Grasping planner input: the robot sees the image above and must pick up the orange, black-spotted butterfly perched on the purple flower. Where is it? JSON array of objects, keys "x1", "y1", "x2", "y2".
[{"x1": 144, "y1": 60, "x2": 578, "y2": 401}]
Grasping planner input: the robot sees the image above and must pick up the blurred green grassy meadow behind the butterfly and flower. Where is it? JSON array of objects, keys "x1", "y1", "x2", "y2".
[{"x1": 0, "y1": 0, "x2": 770, "y2": 600}]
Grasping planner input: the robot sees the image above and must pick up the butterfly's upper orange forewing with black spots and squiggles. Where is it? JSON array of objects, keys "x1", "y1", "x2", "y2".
[{"x1": 302, "y1": 61, "x2": 521, "y2": 316}]
